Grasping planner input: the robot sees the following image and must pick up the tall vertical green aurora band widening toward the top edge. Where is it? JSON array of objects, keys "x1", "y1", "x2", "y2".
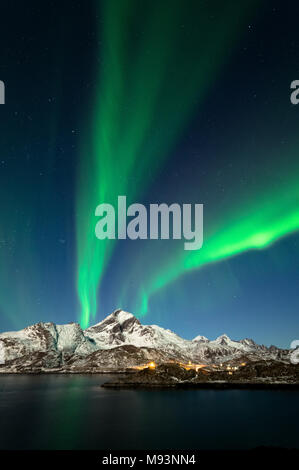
[{"x1": 76, "y1": 0, "x2": 254, "y2": 328}]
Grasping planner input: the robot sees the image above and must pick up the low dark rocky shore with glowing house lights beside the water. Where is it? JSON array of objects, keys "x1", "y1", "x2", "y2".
[{"x1": 102, "y1": 361, "x2": 299, "y2": 389}]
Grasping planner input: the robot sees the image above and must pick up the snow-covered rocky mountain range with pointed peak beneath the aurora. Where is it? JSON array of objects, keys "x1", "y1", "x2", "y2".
[{"x1": 0, "y1": 310, "x2": 290, "y2": 373}]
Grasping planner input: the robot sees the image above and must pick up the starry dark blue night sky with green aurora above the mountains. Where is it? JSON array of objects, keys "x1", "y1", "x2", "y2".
[{"x1": 0, "y1": 0, "x2": 299, "y2": 347}]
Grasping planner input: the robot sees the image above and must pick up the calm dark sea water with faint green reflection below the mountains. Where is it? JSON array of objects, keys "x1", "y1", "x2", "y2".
[{"x1": 0, "y1": 375, "x2": 299, "y2": 450}]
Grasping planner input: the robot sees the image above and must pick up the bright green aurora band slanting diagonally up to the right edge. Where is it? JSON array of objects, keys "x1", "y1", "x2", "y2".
[{"x1": 135, "y1": 168, "x2": 299, "y2": 315}]
